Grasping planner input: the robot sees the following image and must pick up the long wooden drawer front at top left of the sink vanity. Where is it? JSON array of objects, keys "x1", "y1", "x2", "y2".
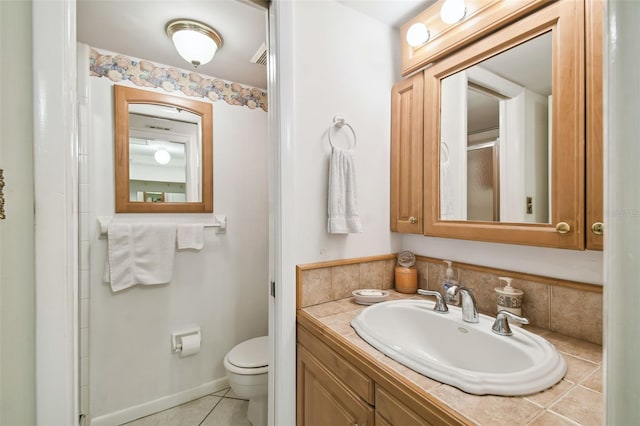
[{"x1": 298, "y1": 326, "x2": 374, "y2": 405}]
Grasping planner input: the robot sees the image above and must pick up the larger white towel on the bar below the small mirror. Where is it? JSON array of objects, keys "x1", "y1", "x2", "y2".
[{"x1": 105, "y1": 223, "x2": 176, "y2": 292}]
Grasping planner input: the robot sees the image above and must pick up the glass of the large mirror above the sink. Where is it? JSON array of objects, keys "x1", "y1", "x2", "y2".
[{"x1": 440, "y1": 32, "x2": 552, "y2": 223}]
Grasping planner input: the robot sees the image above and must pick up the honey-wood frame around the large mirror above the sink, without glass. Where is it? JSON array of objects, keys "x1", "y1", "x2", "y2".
[{"x1": 424, "y1": 0, "x2": 585, "y2": 250}]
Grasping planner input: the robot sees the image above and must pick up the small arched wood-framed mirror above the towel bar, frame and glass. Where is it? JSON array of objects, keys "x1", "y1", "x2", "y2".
[{"x1": 114, "y1": 85, "x2": 213, "y2": 213}]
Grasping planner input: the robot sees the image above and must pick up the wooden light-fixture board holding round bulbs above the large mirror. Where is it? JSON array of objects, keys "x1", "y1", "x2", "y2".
[{"x1": 400, "y1": 0, "x2": 555, "y2": 77}]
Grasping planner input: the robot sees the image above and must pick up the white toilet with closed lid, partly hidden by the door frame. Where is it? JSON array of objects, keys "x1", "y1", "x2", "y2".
[{"x1": 224, "y1": 336, "x2": 269, "y2": 426}]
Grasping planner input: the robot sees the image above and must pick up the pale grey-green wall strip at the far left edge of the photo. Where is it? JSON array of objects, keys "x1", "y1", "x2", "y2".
[{"x1": 0, "y1": 1, "x2": 36, "y2": 425}]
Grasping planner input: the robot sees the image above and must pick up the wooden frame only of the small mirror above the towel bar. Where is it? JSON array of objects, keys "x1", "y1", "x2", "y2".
[{"x1": 113, "y1": 85, "x2": 213, "y2": 213}]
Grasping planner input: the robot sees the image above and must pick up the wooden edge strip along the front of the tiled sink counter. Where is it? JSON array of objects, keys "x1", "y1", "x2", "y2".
[{"x1": 297, "y1": 310, "x2": 471, "y2": 425}]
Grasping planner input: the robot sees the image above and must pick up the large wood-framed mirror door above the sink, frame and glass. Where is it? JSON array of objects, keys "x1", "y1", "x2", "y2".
[{"x1": 424, "y1": 0, "x2": 585, "y2": 249}]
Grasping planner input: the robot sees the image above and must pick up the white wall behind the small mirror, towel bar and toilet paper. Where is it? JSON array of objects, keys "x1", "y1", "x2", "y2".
[{"x1": 88, "y1": 71, "x2": 268, "y2": 418}]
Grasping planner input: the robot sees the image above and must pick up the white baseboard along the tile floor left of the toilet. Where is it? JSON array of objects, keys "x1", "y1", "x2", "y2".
[{"x1": 89, "y1": 377, "x2": 229, "y2": 426}]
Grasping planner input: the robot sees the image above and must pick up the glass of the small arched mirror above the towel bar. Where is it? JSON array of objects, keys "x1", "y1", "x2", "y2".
[{"x1": 129, "y1": 104, "x2": 202, "y2": 203}]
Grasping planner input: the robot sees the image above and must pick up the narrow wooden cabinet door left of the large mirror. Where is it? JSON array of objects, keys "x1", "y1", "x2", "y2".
[{"x1": 391, "y1": 73, "x2": 424, "y2": 234}]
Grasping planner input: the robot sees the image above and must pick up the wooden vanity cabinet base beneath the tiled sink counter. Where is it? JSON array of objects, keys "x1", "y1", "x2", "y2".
[{"x1": 296, "y1": 313, "x2": 466, "y2": 426}]
